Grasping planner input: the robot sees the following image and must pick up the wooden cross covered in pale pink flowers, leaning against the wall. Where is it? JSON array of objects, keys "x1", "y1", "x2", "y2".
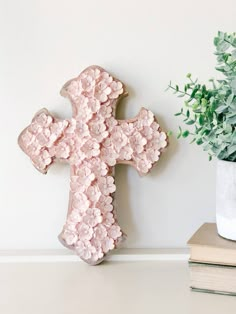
[{"x1": 19, "y1": 66, "x2": 167, "y2": 265}]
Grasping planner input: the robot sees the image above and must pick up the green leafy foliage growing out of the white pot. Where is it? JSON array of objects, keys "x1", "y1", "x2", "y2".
[{"x1": 168, "y1": 32, "x2": 236, "y2": 161}]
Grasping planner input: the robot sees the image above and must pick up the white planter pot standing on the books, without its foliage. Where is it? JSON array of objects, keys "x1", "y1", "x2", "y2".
[{"x1": 216, "y1": 160, "x2": 236, "y2": 240}]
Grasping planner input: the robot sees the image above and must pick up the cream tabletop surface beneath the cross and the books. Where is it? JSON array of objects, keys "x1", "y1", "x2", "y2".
[{"x1": 0, "y1": 262, "x2": 236, "y2": 314}]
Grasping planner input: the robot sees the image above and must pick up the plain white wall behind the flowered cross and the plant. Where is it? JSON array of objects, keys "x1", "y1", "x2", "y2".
[{"x1": 0, "y1": 0, "x2": 236, "y2": 249}]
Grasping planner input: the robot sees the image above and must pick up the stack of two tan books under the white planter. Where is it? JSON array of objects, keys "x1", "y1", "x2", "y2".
[{"x1": 188, "y1": 223, "x2": 236, "y2": 296}]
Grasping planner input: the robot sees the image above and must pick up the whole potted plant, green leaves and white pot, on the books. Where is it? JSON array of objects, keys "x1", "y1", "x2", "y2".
[{"x1": 168, "y1": 32, "x2": 236, "y2": 240}]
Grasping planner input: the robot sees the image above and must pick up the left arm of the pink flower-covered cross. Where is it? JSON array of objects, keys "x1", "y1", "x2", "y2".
[{"x1": 18, "y1": 109, "x2": 74, "y2": 173}]
